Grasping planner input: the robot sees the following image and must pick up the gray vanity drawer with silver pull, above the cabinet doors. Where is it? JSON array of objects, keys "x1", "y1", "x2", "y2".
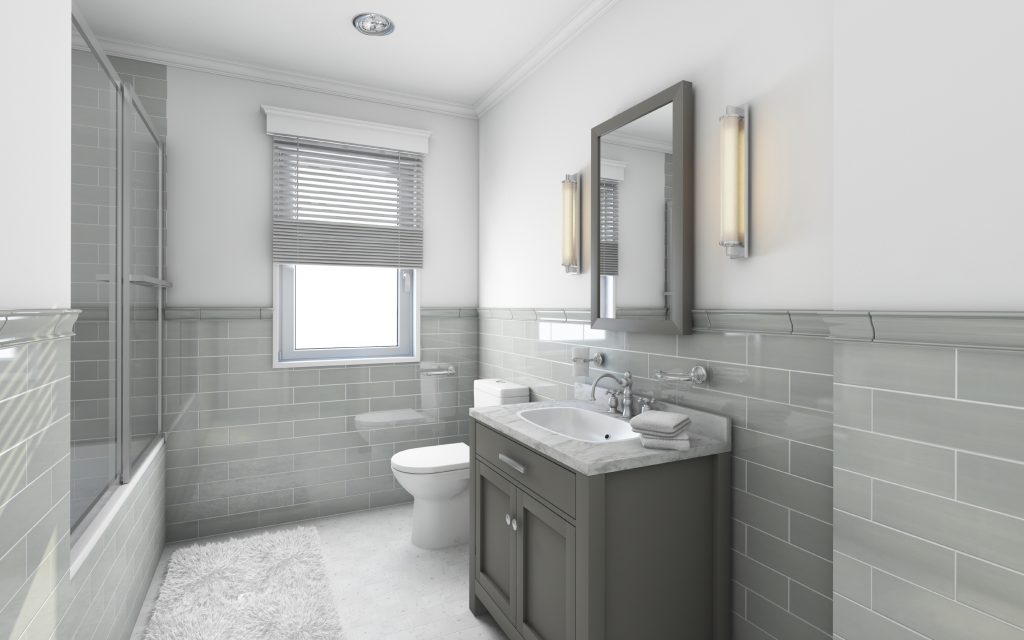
[{"x1": 475, "y1": 423, "x2": 575, "y2": 517}]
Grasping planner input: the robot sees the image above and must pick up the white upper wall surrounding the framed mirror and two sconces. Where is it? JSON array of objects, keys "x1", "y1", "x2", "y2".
[{"x1": 480, "y1": 0, "x2": 831, "y2": 308}]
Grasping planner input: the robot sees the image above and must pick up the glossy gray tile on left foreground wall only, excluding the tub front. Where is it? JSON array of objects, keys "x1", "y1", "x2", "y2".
[{"x1": 0, "y1": 311, "x2": 76, "y2": 638}]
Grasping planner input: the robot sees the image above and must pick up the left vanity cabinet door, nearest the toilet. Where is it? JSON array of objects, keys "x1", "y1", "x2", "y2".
[{"x1": 473, "y1": 463, "x2": 517, "y2": 622}]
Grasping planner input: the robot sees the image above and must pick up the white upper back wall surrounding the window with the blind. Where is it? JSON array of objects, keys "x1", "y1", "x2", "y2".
[{"x1": 167, "y1": 68, "x2": 477, "y2": 306}]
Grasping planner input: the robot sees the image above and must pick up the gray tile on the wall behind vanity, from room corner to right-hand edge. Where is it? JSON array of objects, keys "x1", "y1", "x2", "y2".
[{"x1": 479, "y1": 309, "x2": 833, "y2": 640}]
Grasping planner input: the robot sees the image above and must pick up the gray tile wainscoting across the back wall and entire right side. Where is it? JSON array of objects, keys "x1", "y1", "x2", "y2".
[{"x1": 153, "y1": 309, "x2": 1024, "y2": 640}]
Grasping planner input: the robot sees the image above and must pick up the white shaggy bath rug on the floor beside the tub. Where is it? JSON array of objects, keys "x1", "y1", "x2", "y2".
[{"x1": 144, "y1": 527, "x2": 342, "y2": 640}]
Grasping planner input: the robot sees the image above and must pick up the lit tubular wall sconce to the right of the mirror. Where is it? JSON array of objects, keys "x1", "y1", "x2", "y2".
[{"x1": 718, "y1": 106, "x2": 751, "y2": 258}]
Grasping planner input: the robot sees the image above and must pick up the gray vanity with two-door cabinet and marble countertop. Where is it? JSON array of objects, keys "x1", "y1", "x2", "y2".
[{"x1": 469, "y1": 401, "x2": 731, "y2": 640}]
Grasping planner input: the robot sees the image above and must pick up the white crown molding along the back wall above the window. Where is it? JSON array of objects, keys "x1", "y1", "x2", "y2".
[{"x1": 91, "y1": 36, "x2": 475, "y2": 119}]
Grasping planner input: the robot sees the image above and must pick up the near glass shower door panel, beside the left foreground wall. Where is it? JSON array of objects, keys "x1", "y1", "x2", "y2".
[{"x1": 71, "y1": 22, "x2": 121, "y2": 527}]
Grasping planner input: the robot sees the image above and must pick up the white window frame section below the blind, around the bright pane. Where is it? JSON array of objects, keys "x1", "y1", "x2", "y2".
[{"x1": 273, "y1": 263, "x2": 420, "y2": 369}]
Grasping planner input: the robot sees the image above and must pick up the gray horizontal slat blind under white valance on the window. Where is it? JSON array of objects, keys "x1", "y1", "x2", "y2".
[{"x1": 273, "y1": 135, "x2": 423, "y2": 268}]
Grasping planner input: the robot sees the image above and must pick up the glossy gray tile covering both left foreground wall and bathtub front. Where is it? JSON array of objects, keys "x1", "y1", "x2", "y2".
[{"x1": 0, "y1": 310, "x2": 164, "y2": 640}]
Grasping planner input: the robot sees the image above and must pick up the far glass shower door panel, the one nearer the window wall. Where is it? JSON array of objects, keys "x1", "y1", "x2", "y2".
[{"x1": 122, "y1": 87, "x2": 168, "y2": 468}]
